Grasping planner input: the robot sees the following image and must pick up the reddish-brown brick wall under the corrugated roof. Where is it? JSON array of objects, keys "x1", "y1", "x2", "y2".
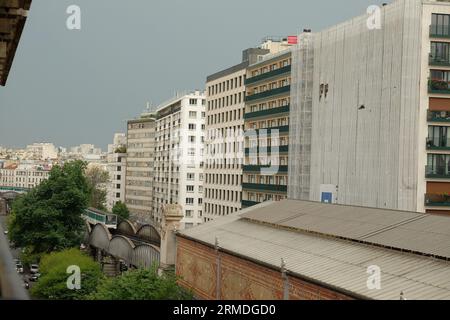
[{"x1": 176, "y1": 237, "x2": 351, "y2": 300}]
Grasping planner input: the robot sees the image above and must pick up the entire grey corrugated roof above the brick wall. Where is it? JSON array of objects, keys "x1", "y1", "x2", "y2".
[{"x1": 180, "y1": 201, "x2": 450, "y2": 300}]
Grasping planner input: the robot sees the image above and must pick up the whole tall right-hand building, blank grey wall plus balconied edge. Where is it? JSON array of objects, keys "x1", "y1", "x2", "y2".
[{"x1": 289, "y1": 0, "x2": 450, "y2": 213}]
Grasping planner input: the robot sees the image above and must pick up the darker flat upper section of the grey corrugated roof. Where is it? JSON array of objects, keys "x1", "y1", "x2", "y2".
[{"x1": 241, "y1": 200, "x2": 450, "y2": 259}]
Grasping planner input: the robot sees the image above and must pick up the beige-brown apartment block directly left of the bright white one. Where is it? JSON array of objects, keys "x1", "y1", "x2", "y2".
[{"x1": 125, "y1": 113, "x2": 155, "y2": 223}]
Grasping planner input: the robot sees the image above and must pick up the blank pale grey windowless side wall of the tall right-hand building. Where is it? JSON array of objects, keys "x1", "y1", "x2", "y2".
[{"x1": 290, "y1": 0, "x2": 422, "y2": 211}]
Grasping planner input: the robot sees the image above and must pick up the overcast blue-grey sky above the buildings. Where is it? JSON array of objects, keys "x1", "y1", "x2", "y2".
[{"x1": 0, "y1": 0, "x2": 384, "y2": 148}]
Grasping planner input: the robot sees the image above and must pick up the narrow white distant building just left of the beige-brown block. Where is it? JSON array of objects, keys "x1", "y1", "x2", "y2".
[{"x1": 106, "y1": 133, "x2": 127, "y2": 210}]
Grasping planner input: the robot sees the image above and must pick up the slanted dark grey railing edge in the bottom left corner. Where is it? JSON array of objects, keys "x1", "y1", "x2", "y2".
[{"x1": 0, "y1": 222, "x2": 29, "y2": 300}]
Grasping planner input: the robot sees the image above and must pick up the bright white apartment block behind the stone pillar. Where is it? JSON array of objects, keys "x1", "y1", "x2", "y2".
[{"x1": 153, "y1": 91, "x2": 206, "y2": 228}]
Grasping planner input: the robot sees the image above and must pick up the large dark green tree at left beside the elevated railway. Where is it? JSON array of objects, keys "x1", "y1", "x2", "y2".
[{"x1": 8, "y1": 161, "x2": 90, "y2": 255}]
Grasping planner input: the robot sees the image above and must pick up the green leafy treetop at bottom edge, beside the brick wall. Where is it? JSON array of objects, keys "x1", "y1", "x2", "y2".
[{"x1": 90, "y1": 267, "x2": 193, "y2": 300}]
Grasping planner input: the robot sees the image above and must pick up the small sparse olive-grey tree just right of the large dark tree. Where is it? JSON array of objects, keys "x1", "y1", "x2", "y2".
[{"x1": 85, "y1": 165, "x2": 109, "y2": 211}]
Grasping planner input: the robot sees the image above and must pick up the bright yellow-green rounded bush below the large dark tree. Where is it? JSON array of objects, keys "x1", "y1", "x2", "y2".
[{"x1": 31, "y1": 249, "x2": 103, "y2": 300}]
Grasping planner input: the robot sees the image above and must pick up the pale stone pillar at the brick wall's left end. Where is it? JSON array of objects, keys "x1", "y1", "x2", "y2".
[{"x1": 159, "y1": 204, "x2": 184, "y2": 271}]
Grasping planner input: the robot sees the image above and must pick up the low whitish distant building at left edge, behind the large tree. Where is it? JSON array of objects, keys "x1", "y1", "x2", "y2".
[{"x1": 0, "y1": 163, "x2": 51, "y2": 189}]
